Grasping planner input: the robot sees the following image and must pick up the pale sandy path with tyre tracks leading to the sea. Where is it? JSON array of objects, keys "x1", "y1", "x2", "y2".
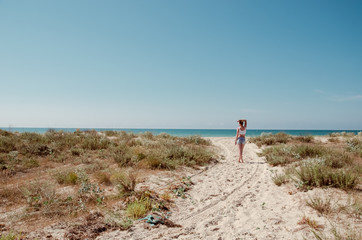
[{"x1": 97, "y1": 138, "x2": 316, "y2": 239}]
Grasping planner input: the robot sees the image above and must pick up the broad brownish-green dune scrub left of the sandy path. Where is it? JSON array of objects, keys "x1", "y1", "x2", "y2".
[{"x1": 0, "y1": 130, "x2": 216, "y2": 239}]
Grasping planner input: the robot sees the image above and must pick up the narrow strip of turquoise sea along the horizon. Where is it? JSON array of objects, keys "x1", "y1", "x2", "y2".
[{"x1": 0, "y1": 127, "x2": 362, "y2": 137}]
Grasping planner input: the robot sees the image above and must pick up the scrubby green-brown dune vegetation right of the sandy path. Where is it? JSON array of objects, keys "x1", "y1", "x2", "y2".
[{"x1": 251, "y1": 133, "x2": 362, "y2": 240}]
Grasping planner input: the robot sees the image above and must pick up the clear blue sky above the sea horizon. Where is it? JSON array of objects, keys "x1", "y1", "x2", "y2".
[{"x1": 0, "y1": 0, "x2": 362, "y2": 129}]
